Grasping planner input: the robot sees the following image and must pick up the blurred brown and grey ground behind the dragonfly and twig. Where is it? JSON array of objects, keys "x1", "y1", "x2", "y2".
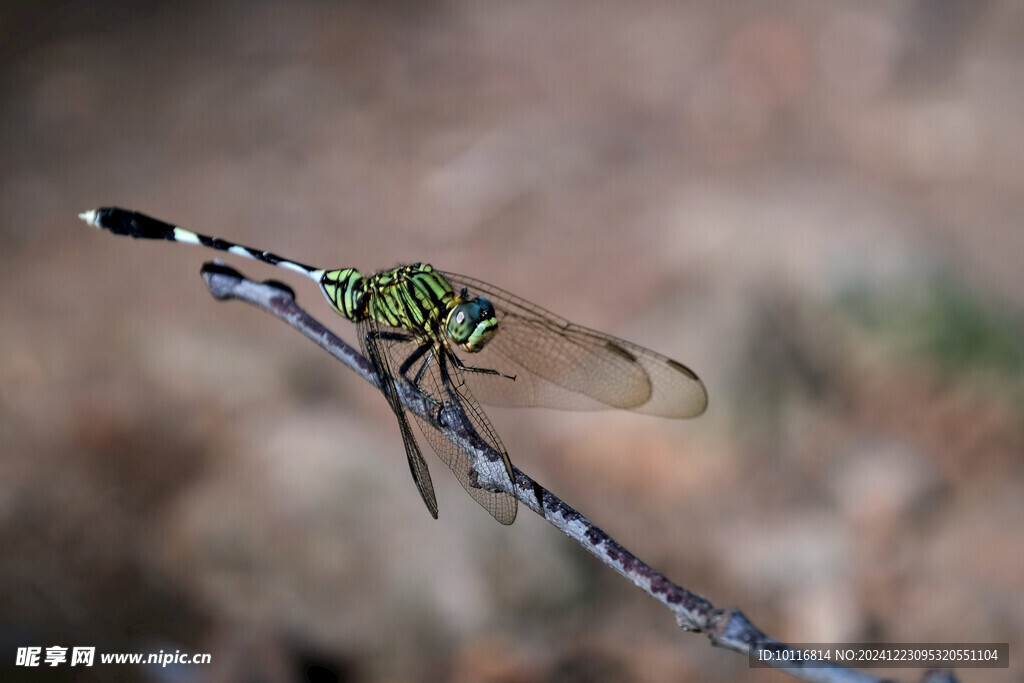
[{"x1": 0, "y1": 0, "x2": 1024, "y2": 681}]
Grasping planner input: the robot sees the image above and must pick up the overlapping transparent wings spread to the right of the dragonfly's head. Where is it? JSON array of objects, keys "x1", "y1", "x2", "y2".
[{"x1": 441, "y1": 272, "x2": 708, "y2": 418}]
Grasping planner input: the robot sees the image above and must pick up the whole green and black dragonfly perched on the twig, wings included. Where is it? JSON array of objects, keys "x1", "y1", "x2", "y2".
[{"x1": 79, "y1": 207, "x2": 708, "y2": 524}]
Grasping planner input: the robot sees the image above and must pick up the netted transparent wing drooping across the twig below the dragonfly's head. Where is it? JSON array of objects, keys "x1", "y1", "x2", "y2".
[{"x1": 362, "y1": 322, "x2": 517, "y2": 524}]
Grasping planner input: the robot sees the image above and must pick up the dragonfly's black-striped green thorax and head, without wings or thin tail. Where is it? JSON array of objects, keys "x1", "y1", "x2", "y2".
[{"x1": 321, "y1": 263, "x2": 498, "y2": 352}]
